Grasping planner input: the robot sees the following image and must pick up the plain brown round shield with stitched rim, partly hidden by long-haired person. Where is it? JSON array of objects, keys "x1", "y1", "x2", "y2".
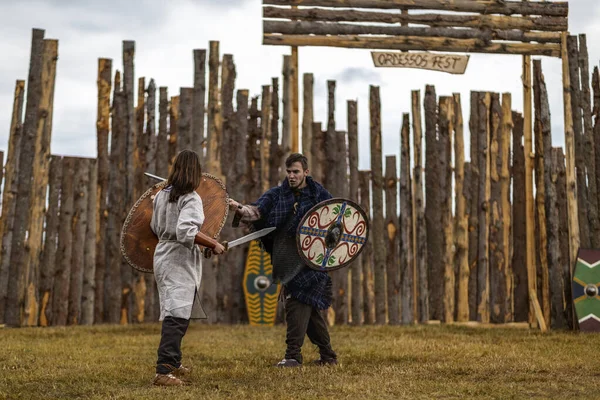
[{"x1": 121, "y1": 173, "x2": 229, "y2": 272}]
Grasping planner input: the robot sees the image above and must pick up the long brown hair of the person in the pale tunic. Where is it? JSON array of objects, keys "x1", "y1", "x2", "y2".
[{"x1": 167, "y1": 150, "x2": 202, "y2": 202}]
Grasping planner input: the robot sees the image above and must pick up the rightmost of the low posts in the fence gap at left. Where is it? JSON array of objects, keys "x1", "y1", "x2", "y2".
[{"x1": 81, "y1": 158, "x2": 97, "y2": 325}]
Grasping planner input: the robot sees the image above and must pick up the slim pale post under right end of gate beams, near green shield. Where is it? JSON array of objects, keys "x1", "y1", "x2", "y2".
[{"x1": 561, "y1": 32, "x2": 579, "y2": 328}]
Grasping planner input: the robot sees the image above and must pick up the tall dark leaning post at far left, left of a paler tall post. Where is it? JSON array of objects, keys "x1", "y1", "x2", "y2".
[{"x1": 5, "y1": 29, "x2": 45, "y2": 326}]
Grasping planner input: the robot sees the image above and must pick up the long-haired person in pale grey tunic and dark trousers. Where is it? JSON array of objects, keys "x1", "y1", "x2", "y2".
[{"x1": 150, "y1": 150, "x2": 225, "y2": 386}]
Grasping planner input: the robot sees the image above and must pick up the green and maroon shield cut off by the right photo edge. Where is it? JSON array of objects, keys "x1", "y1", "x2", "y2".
[{"x1": 573, "y1": 249, "x2": 600, "y2": 332}]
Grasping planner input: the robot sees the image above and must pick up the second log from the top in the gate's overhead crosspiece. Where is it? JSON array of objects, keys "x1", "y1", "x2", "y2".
[{"x1": 263, "y1": 7, "x2": 569, "y2": 32}]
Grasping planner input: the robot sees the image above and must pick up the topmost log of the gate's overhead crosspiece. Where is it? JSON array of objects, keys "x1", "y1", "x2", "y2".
[{"x1": 263, "y1": 0, "x2": 569, "y2": 17}]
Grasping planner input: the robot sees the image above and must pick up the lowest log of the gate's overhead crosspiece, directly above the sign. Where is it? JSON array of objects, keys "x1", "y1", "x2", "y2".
[{"x1": 263, "y1": 34, "x2": 560, "y2": 57}]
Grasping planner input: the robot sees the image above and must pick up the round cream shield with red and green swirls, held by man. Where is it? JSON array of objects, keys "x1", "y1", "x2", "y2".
[{"x1": 296, "y1": 198, "x2": 369, "y2": 271}]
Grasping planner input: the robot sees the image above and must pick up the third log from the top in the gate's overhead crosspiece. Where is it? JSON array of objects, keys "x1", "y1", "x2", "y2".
[{"x1": 263, "y1": 21, "x2": 561, "y2": 42}]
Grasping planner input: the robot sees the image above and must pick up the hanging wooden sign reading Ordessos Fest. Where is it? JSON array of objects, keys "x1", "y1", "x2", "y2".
[{"x1": 371, "y1": 51, "x2": 469, "y2": 74}]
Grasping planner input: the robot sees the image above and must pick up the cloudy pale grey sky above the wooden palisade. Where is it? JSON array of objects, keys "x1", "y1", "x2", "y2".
[{"x1": 0, "y1": 0, "x2": 600, "y2": 169}]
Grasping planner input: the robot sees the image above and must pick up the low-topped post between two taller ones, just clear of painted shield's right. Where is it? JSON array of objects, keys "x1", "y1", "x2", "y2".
[{"x1": 384, "y1": 156, "x2": 404, "y2": 325}]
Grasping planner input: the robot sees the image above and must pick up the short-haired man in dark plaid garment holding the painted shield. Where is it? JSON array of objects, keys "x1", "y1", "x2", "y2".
[{"x1": 230, "y1": 153, "x2": 337, "y2": 367}]
